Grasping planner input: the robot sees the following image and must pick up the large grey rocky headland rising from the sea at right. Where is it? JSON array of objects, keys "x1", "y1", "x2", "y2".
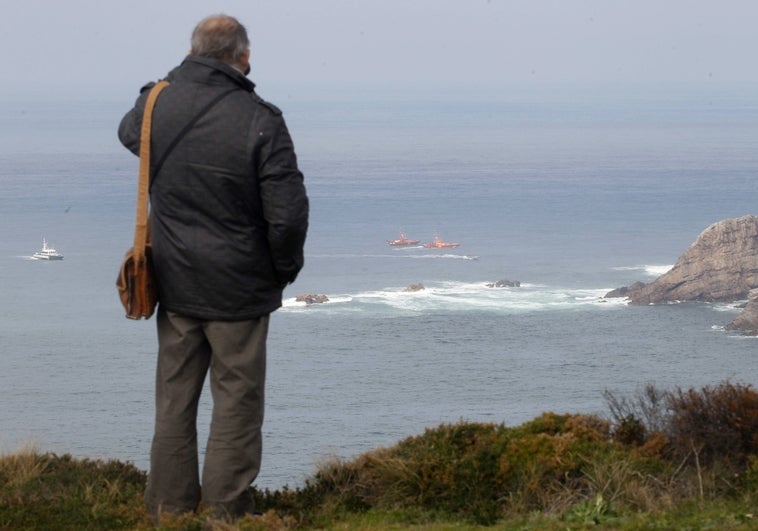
[{"x1": 606, "y1": 216, "x2": 758, "y2": 304}]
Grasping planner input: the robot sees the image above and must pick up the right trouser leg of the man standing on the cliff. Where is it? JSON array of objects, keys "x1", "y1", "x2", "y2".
[{"x1": 202, "y1": 315, "x2": 269, "y2": 518}]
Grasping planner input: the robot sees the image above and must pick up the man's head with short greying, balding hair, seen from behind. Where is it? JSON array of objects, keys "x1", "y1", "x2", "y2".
[{"x1": 190, "y1": 15, "x2": 250, "y2": 72}]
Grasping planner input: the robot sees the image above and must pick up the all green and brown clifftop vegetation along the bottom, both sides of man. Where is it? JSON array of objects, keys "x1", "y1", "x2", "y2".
[{"x1": 0, "y1": 382, "x2": 758, "y2": 530}]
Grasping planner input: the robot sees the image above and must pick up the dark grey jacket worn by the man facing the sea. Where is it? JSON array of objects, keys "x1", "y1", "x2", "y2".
[{"x1": 118, "y1": 56, "x2": 308, "y2": 321}]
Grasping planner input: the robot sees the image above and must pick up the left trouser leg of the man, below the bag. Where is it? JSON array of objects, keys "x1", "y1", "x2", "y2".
[{"x1": 145, "y1": 308, "x2": 210, "y2": 522}]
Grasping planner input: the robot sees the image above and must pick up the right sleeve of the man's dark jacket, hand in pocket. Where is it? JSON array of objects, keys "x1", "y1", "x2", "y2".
[{"x1": 258, "y1": 114, "x2": 309, "y2": 286}]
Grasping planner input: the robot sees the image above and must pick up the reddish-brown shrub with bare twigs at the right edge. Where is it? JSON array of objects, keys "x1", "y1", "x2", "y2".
[{"x1": 604, "y1": 381, "x2": 758, "y2": 499}]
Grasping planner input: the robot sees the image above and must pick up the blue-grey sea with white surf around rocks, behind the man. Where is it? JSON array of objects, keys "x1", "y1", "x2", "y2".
[{"x1": 0, "y1": 86, "x2": 758, "y2": 489}]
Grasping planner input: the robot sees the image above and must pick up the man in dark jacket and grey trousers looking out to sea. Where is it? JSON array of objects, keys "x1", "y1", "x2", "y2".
[{"x1": 118, "y1": 15, "x2": 308, "y2": 522}]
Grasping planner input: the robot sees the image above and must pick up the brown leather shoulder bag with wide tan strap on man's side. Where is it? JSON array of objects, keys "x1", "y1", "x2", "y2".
[{"x1": 116, "y1": 81, "x2": 168, "y2": 319}]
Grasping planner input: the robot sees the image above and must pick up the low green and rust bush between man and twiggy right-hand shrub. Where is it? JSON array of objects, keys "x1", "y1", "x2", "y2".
[{"x1": 260, "y1": 413, "x2": 640, "y2": 525}]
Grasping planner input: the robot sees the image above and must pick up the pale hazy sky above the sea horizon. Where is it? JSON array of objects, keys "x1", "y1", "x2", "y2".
[{"x1": 5, "y1": 0, "x2": 758, "y2": 97}]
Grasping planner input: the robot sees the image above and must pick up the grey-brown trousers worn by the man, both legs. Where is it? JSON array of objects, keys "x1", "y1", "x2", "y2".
[{"x1": 145, "y1": 307, "x2": 269, "y2": 522}]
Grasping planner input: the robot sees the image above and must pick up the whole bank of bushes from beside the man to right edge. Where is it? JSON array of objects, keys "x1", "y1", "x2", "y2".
[{"x1": 280, "y1": 382, "x2": 758, "y2": 524}]
